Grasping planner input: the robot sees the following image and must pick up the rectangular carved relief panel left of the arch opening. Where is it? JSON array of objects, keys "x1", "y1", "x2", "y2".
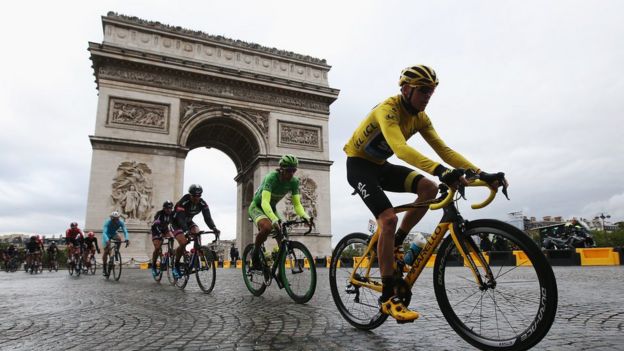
[{"x1": 108, "y1": 98, "x2": 169, "y2": 131}]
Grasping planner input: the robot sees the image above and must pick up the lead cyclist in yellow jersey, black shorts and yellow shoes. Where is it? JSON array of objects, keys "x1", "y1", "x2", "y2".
[{"x1": 344, "y1": 65, "x2": 508, "y2": 321}]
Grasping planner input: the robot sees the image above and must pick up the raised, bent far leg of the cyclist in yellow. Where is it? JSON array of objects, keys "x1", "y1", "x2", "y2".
[{"x1": 380, "y1": 162, "x2": 438, "y2": 246}]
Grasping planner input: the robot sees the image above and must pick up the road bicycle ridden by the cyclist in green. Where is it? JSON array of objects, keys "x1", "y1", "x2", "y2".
[{"x1": 242, "y1": 221, "x2": 316, "y2": 303}]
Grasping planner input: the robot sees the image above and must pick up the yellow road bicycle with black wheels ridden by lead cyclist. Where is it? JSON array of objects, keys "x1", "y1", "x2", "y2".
[{"x1": 329, "y1": 179, "x2": 557, "y2": 350}]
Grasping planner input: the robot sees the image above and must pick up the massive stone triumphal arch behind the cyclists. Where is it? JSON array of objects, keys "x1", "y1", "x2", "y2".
[{"x1": 85, "y1": 12, "x2": 338, "y2": 261}]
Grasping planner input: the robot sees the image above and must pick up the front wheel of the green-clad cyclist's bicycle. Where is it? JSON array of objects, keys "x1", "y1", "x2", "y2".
[{"x1": 279, "y1": 241, "x2": 316, "y2": 303}]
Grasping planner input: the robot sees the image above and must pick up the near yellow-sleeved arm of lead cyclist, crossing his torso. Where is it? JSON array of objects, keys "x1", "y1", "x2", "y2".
[{"x1": 375, "y1": 109, "x2": 439, "y2": 174}]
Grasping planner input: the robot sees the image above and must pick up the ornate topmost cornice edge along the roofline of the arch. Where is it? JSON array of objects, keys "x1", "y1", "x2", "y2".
[{"x1": 102, "y1": 11, "x2": 331, "y2": 69}]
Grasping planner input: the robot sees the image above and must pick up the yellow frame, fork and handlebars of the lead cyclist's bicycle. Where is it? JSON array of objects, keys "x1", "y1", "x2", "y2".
[{"x1": 350, "y1": 180, "x2": 497, "y2": 292}]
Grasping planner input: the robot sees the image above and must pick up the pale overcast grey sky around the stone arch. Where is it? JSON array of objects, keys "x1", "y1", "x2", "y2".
[{"x1": 0, "y1": 1, "x2": 624, "y2": 242}]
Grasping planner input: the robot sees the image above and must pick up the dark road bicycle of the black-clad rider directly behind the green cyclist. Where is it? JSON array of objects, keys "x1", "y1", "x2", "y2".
[{"x1": 172, "y1": 231, "x2": 218, "y2": 294}]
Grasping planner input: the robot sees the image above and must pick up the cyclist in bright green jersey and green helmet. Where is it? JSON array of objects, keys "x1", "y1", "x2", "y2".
[{"x1": 249, "y1": 155, "x2": 312, "y2": 270}]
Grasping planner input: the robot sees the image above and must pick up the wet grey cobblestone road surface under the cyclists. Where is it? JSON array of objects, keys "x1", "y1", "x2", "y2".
[{"x1": 0, "y1": 266, "x2": 624, "y2": 350}]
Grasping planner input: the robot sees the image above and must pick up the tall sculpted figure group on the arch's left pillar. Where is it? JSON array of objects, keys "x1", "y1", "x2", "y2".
[{"x1": 111, "y1": 161, "x2": 154, "y2": 221}]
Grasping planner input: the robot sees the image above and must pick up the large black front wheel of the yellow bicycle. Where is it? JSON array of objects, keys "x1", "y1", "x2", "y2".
[{"x1": 433, "y1": 219, "x2": 557, "y2": 351}]
